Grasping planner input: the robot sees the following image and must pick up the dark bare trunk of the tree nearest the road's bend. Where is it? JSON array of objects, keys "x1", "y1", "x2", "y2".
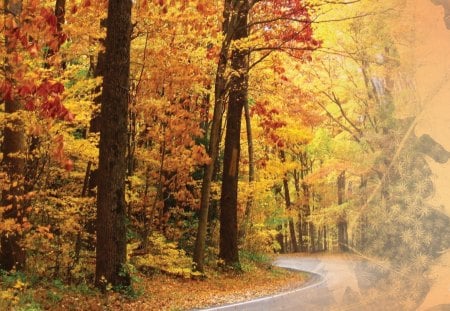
[{"x1": 219, "y1": 1, "x2": 248, "y2": 266}]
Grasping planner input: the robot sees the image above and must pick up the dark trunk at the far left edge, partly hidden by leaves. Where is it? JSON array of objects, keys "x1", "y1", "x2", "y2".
[{"x1": 0, "y1": 0, "x2": 27, "y2": 270}]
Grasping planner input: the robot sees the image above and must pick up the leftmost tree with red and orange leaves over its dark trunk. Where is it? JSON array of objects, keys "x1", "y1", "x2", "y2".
[{"x1": 1, "y1": 1, "x2": 69, "y2": 269}]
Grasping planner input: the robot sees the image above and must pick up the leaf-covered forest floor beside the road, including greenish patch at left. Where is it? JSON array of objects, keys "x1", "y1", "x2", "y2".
[{"x1": 0, "y1": 264, "x2": 308, "y2": 311}]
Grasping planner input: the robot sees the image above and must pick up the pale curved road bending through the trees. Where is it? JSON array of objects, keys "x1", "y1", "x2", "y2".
[{"x1": 200, "y1": 255, "x2": 400, "y2": 311}]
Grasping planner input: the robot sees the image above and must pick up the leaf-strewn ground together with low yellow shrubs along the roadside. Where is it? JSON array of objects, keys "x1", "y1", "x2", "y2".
[{"x1": 0, "y1": 233, "x2": 304, "y2": 311}]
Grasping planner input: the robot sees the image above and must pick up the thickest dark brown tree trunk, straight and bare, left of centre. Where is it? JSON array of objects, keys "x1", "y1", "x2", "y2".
[{"x1": 95, "y1": 0, "x2": 132, "y2": 287}]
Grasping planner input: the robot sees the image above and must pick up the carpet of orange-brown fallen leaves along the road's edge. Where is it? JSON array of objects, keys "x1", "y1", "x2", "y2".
[{"x1": 40, "y1": 267, "x2": 308, "y2": 311}]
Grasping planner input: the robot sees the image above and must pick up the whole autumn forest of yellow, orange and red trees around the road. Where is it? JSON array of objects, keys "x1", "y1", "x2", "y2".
[{"x1": 0, "y1": 0, "x2": 450, "y2": 310}]
